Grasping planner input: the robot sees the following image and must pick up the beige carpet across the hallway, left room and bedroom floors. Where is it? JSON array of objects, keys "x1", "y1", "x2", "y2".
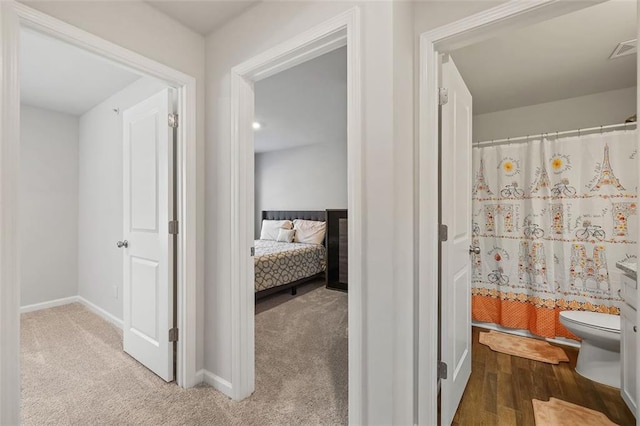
[{"x1": 22, "y1": 283, "x2": 348, "y2": 425}]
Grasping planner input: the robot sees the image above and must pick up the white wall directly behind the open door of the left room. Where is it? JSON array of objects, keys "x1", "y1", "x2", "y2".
[{"x1": 77, "y1": 78, "x2": 165, "y2": 319}]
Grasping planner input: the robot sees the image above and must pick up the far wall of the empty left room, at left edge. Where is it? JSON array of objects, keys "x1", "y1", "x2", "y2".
[{"x1": 19, "y1": 105, "x2": 78, "y2": 306}]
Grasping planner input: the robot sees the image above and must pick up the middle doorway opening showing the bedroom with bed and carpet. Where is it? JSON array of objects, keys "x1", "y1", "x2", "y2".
[{"x1": 251, "y1": 47, "x2": 348, "y2": 423}]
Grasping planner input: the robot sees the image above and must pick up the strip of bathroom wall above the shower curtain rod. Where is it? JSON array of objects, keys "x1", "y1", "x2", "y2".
[{"x1": 472, "y1": 87, "x2": 636, "y2": 142}]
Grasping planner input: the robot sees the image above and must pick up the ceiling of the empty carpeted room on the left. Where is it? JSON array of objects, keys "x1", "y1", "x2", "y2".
[{"x1": 20, "y1": 29, "x2": 140, "y2": 115}]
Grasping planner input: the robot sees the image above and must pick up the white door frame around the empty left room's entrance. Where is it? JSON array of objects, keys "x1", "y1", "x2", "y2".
[{"x1": 0, "y1": 2, "x2": 197, "y2": 424}]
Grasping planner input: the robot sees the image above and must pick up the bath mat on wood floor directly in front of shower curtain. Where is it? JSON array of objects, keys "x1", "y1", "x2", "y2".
[{"x1": 480, "y1": 330, "x2": 569, "y2": 364}]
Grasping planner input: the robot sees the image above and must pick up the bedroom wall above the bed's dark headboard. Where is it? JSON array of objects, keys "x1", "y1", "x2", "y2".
[{"x1": 255, "y1": 142, "x2": 347, "y2": 238}]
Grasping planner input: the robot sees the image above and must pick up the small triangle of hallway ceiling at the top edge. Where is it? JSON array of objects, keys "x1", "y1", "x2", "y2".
[{"x1": 147, "y1": 0, "x2": 259, "y2": 36}]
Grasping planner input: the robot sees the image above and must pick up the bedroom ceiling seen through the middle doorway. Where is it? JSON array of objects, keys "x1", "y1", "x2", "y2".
[{"x1": 254, "y1": 47, "x2": 347, "y2": 153}]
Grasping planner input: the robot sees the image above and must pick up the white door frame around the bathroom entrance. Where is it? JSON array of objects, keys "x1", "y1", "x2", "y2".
[{"x1": 417, "y1": 0, "x2": 612, "y2": 425}]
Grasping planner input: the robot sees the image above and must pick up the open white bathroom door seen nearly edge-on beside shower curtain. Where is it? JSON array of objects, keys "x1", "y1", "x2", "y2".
[{"x1": 440, "y1": 57, "x2": 472, "y2": 425}]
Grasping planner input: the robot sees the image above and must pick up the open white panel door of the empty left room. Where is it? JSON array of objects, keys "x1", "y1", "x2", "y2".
[{"x1": 119, "y1": 89, "x2": 173, "y2": 381}]
